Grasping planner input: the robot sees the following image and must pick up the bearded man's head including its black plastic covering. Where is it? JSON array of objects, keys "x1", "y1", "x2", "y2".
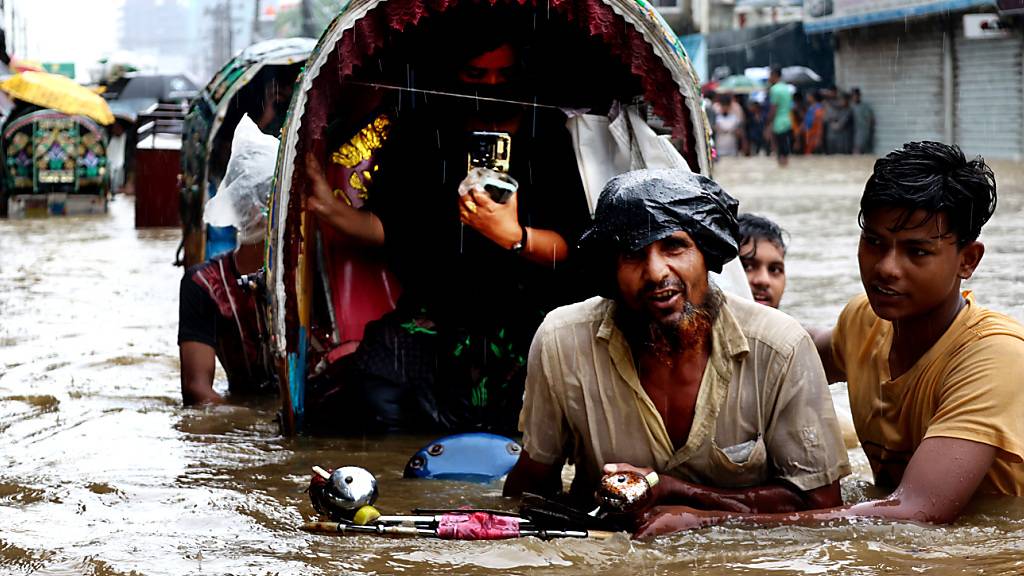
[{"x1": 581, "y1": 170, "x2": 738, "y2": 352}]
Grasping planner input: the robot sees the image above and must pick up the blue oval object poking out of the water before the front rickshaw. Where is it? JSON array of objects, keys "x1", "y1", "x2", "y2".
[{"x1": 403, "y1": 433, "x2": 522, "y2": 483}]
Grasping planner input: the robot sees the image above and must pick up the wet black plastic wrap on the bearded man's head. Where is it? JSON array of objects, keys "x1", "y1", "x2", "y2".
[{"x1": 580, "y1": 170, "x2": 739, "y2": 273}]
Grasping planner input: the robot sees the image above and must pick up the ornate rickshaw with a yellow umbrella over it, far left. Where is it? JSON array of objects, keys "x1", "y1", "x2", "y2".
[{"x1": 0, "y1": 72, "x2": 114, "y2": 217}]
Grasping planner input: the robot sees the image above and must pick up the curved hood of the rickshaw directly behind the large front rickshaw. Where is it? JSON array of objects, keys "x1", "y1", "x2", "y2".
[{"x1": 179, "y1": 38, "x2": 315, "y2": 269}]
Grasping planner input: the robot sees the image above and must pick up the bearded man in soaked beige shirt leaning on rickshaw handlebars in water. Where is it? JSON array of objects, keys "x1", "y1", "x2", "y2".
[{"x1": 505, "y1": 170, "x2": 849, "y2": 516}]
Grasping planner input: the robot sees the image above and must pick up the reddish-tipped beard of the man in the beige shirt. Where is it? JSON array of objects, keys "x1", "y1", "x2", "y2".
[{"x1": 618, "y1": 282, "x2": 725, "y2": 364}]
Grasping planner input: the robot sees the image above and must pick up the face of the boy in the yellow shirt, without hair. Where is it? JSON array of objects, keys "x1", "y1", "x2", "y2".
[{"x1": 857, "y1": 208, "x2": 983, "y2": 321}]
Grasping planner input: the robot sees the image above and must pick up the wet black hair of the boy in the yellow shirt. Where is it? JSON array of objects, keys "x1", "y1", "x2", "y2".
[{"x1": 857, "y1": 141, "x2": 996, "y2": 247}]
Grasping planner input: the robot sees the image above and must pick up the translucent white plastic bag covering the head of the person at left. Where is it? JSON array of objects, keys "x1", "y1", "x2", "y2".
[{"x1": 203, "y1": 114, "x2": 280, "y2": 244}]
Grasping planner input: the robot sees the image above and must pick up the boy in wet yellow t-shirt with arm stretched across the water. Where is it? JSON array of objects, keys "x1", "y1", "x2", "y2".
[{"x1": 626, "y1": 141, "x2": 1024, "y2": 536}]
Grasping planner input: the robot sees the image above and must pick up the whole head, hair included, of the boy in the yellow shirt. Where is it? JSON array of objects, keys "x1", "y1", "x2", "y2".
[{"x1": 857, "y1": 141, "x2": 996, "y2": 321}]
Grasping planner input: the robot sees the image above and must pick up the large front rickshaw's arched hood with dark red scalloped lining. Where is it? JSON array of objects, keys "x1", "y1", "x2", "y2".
[{"x1": 265, "y1": 0, "x2": 720, "y2": 434}]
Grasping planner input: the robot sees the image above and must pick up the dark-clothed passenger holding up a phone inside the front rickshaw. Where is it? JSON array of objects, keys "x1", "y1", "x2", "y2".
[{"x1": 306, "y1": 7, "x2": 632, "y2": 433}]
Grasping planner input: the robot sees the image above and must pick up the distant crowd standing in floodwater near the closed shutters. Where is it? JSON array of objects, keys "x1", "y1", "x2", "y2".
[{"x1": 705, "y1": 71, "x2": 874, "y2": 164}]
